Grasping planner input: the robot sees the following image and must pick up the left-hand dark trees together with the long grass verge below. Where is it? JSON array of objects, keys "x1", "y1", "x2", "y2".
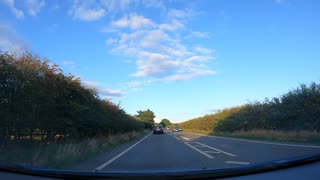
[{"x1": 0, "y1": 52, "x2": 155, "y2": 167}]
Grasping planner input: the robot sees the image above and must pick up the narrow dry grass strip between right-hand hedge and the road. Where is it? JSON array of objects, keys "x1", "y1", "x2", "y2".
[{"x1": 184, "y1": 129, "x2": 320, "y2": 145}]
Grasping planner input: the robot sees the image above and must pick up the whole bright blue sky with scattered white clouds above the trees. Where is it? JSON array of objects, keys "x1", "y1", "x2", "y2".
[{"x1": 0, "y1": 0, "x2": 320, "y2": 122}]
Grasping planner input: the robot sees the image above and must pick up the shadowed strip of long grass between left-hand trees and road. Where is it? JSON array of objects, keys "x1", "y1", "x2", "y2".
[{"x1": 0, "y1": 131, "x2": 147, "y2": 168}]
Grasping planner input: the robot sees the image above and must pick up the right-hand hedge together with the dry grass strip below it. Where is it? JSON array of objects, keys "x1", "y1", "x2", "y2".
[{"x1": 179, "y1": 82, "x2": 320, "y2": 144}]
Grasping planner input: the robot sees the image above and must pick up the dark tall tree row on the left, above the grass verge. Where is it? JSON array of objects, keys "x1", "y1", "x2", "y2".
[{"x1": 0, "y1": 52, "x2": 145, "y2": 145}]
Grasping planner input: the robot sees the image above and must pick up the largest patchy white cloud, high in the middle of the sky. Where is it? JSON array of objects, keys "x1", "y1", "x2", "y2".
[{"x1": 106, "y1": 9, "x2": 215, "y2": 81}]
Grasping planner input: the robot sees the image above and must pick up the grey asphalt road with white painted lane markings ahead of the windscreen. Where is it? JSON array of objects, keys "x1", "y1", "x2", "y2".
[{"x1": 73, "y1": 131, "x2": 320, "y2": 172}]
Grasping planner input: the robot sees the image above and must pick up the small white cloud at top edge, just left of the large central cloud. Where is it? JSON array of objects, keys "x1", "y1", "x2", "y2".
[{"x1": 69, "y1": 0, "x2": 106, "y2": 21}]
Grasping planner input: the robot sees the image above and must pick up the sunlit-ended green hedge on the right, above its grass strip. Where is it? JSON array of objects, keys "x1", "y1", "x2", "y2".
[{"x1": 180, "y1": 82, "x2": 320, "y2": 132}]
